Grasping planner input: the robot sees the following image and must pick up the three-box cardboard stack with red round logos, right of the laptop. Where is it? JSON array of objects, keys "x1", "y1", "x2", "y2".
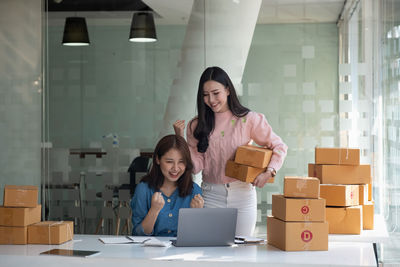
[{"x1": 267, "y1": 177, "x2": 328, "y2": 251}]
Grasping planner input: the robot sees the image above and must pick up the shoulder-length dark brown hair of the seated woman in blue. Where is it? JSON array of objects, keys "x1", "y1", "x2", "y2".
[{"x1": 141, "y1": 134, "x2": 193, "y2": 197}]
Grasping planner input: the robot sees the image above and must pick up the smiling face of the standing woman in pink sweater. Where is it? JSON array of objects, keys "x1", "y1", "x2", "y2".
[{"x1": 203, "y1": 80, "x2": 229, "y2": 113}]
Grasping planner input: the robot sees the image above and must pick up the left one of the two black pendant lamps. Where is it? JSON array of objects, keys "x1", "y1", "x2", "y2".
[{"x1": 62, "y1": 17, "x2": 90, "y2": 46}]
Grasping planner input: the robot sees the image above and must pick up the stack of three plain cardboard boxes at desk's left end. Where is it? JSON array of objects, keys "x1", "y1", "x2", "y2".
[{"x1": 0, "y1": 185, "x2": 74, "y2": 245}]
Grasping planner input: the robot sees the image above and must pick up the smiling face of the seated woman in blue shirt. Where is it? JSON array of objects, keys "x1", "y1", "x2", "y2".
[{"x1": 157, "y1": 148, "x2": 186, "y2": 183}]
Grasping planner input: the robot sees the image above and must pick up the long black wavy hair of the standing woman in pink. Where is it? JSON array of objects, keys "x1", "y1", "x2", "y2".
[{"x1": 190, "y1": 67, "x2": 250, "y2": 153}]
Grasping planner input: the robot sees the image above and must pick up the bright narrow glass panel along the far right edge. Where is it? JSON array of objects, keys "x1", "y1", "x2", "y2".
[{"x1": 380, "y1": 1, "x2": 400, "y2": 237}]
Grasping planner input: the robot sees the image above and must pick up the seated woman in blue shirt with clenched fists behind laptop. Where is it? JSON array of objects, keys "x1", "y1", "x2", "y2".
[{"x1": 131, "y1": 135, "x2": 204, "y2": 236}]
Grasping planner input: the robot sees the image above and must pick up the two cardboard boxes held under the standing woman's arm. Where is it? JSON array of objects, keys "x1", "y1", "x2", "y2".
[{"x1": 225, "y1": 145, "x2": 274, "y2": 183}]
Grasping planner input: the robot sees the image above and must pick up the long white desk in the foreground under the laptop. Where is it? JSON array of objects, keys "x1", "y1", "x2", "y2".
[{"x1": 0, "y1": 235, "x2": 376, "y2": 267}]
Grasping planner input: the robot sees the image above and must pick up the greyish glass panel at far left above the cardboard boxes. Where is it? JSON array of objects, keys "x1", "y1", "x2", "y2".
[{"x1": 0, "y1": 0, "x2": 43, "y2": 209}]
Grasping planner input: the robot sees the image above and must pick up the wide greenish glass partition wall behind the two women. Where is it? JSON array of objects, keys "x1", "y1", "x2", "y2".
[{"x1": 44, "y1": 0, "x2": 343, "y2": 235}]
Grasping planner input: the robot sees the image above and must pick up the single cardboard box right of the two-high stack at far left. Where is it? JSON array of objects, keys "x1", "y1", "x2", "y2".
[{"x1": 28, "y1": 221, "x2": 74, "y2": 245}]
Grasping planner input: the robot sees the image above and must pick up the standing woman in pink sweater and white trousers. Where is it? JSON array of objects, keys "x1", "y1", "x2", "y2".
[{"x1": 174, "y1": 67, "x2": 287, "y2": 236}]
